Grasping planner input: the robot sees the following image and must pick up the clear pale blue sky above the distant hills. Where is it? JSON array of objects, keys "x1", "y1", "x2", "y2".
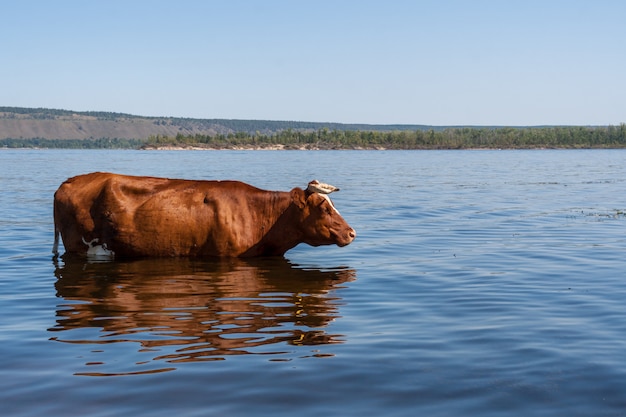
[{"x1": 0, "y1": 0, "x2": 626, "y2": 125}]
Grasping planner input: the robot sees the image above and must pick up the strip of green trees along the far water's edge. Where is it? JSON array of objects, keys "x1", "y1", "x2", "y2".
[{"x1": 0, "y1": 123, "x2": 626, "y2": 150}]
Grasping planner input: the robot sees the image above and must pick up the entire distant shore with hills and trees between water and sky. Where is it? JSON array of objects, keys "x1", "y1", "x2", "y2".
[{"x1": 0, "y1": 107, "x2": 626, "y2": 150}]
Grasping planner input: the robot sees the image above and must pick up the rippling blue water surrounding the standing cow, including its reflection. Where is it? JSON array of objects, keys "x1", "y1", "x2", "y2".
[{"x1": 0, "y1": 150, "x2": 626, "y2": 416}]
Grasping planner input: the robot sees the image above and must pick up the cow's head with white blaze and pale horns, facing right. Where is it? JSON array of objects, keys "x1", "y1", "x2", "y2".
[{"x1": 291, "y1": 182, "x2": 356, "y2": 246}]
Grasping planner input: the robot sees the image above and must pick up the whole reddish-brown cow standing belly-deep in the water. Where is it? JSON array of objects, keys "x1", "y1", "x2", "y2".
[{"x1": 53, "y1": 172, "x2": 356, "y2": 258}]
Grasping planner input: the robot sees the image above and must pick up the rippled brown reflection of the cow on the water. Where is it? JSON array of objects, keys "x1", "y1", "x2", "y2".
[{"x1": 50, "y1": 258, "x2": 355, "y2": 370}]
